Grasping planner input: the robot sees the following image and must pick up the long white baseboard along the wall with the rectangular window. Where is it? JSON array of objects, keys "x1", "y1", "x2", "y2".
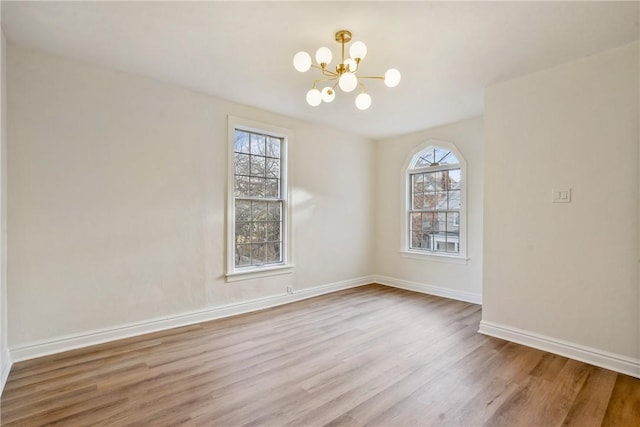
[{"x1": 10, "y1": 276, "x2": 374, "y2": 364}]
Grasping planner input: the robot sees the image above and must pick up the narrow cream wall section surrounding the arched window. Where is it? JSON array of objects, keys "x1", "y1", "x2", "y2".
[{"x1": 375, "y1": 117, "x2": 483, "y2": 299}]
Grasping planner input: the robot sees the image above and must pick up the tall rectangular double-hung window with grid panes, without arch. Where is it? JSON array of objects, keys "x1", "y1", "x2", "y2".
[{"x1": 227, "y1": 117, "x2": 289, "y2": 277}]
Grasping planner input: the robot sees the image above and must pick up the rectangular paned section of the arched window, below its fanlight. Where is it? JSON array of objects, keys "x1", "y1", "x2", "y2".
[{"x1": 409, "y1": 168, "x2": 460, "y2": 255}]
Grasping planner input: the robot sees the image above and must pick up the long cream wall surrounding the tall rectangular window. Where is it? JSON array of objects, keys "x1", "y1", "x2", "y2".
[{"x1": 8, "y1": 44, "x2": 375, "y2": 346}]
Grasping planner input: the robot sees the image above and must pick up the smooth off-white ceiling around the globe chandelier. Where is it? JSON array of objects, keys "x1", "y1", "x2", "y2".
[{"x1": 2, "y1": 1, "x2": 640, "y2": 139}]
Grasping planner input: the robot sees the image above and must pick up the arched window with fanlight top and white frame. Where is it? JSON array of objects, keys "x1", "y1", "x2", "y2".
[{"x1": 403, "y1": 141, "x2": 466, "y2": 258}]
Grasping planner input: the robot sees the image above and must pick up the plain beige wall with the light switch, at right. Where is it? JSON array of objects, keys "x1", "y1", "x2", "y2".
[{"x1": 483, "y1": 43, "x2": 640, "y2": 359}]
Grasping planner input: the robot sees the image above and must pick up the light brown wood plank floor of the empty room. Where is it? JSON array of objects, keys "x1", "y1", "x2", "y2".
[{"x1": 1, "y1": 285, "x2": 640, "y2": 427}]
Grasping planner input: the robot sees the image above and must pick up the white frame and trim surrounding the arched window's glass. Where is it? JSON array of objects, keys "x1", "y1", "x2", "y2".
[{"x1": 400, "y1": 139, "x2": 469, "y2": 264}]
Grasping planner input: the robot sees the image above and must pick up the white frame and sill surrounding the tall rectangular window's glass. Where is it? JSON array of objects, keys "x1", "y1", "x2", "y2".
[{"x1": 226, "y1": 116, "x2": 294, "y2": 282}]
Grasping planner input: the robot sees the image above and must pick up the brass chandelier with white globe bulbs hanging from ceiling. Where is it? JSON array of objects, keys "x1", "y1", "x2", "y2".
[{"x1": 293, "y1": 30, "x2": 400, "y2": 110}]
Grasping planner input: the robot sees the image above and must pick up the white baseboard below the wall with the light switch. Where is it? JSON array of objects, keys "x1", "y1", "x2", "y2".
[{"x1": 478, "y1": 320, "x2": 640, "y2": 378}]
